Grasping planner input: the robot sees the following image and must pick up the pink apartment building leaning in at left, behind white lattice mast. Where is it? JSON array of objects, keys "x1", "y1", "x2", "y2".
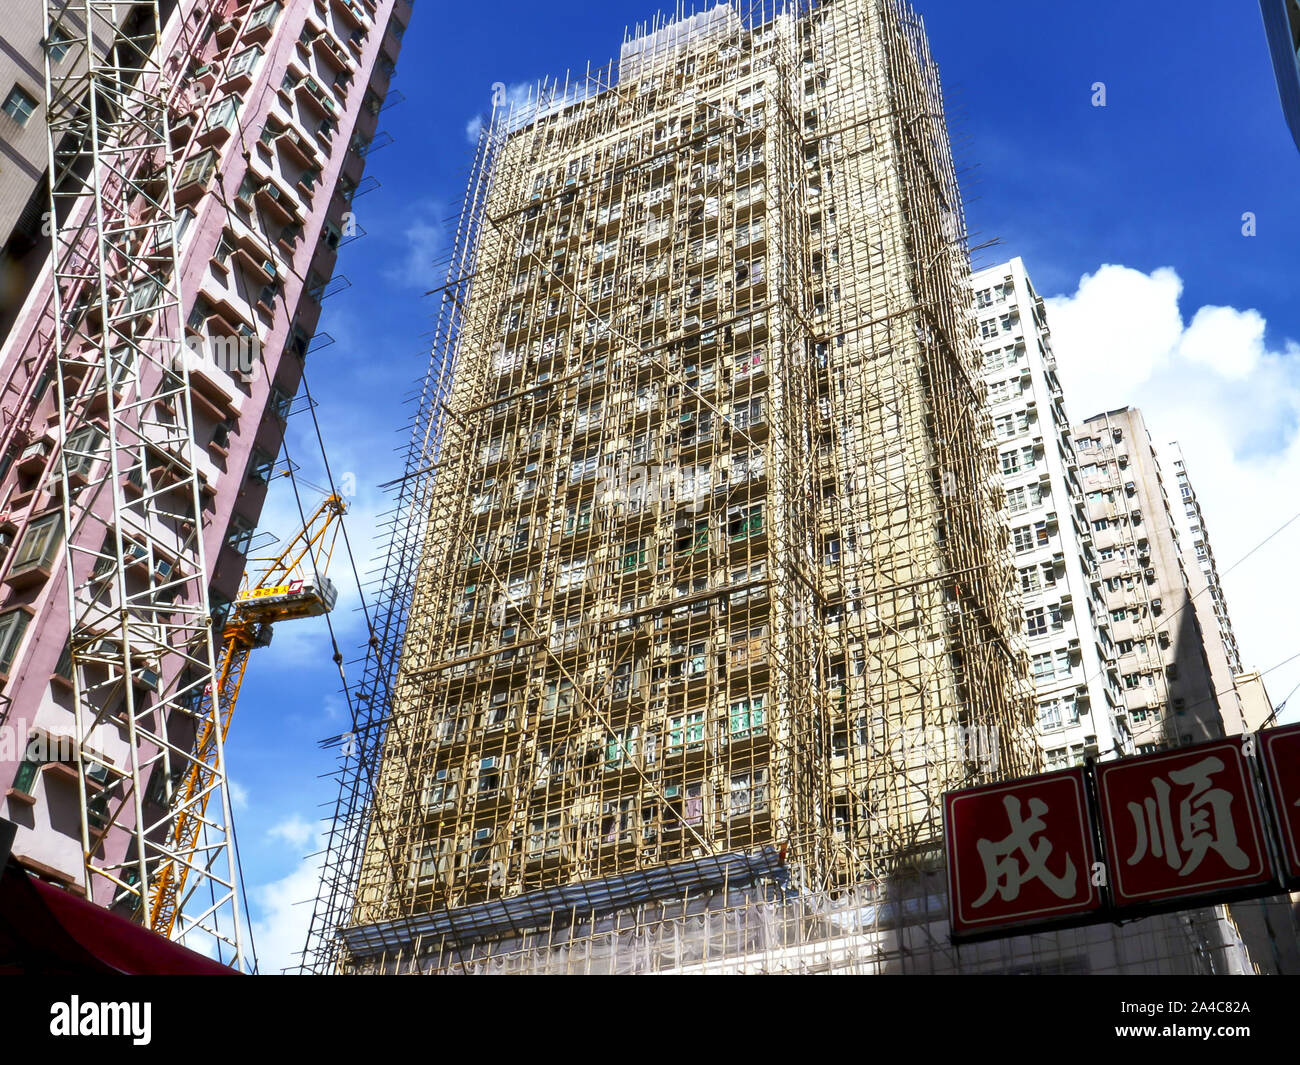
[{"x1": 0, "y1": 0, "x2": 411, "y2": 941}]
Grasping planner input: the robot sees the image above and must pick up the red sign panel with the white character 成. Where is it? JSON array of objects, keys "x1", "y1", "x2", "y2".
[{"x1": 944, "y1": 769, "x2": 1102, "y2": 936}]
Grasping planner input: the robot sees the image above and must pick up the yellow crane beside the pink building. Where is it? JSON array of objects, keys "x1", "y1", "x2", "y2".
[{"x1": 150, "y1": 493, "x2": 347, "y2": 938}]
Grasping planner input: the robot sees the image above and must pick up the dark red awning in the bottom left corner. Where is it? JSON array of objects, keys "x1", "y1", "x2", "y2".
[{"x1": 0, "y1": 862, "x2": 235, "y2": 977}]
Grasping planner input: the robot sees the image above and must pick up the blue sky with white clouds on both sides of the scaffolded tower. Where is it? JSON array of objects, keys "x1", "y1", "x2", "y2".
[{"x1": 228, "y1": 0, "x2": 1300, "y2": 970}]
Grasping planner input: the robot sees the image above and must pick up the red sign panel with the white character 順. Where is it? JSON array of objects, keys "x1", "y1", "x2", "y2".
[{"x1": 1097, "y1": 737, "x2": 1273, "y2": 906}]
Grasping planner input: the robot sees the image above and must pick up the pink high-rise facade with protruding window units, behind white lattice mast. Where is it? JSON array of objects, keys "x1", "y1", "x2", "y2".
[{"x1": 0, "y1": 0, "x2": 411, "y2": 908}]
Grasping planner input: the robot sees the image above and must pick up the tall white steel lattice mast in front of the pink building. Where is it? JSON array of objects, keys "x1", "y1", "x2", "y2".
[{"x1": 43, "y1": 0, "x2": 246, "y2": 967}]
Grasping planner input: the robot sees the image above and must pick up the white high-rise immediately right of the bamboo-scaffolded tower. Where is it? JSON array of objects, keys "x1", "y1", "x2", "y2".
[{"x1": 972, "y1": 259, "x2": 1132, "y2": 769}]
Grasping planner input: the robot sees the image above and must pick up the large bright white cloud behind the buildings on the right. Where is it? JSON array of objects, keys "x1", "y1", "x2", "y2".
[{"x1": 1048, "y1": 265, "x2": 1300, "y2": 719}]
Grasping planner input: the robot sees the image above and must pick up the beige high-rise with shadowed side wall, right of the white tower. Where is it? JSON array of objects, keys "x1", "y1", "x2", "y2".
[{"x1": 1074, "y1": 407, "x2": 1225, "y2": 752}]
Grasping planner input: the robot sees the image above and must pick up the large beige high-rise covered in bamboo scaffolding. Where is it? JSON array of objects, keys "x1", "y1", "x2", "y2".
[{"x1": 346, "y1": 0, "x2": 1039, "y2": 964}]
